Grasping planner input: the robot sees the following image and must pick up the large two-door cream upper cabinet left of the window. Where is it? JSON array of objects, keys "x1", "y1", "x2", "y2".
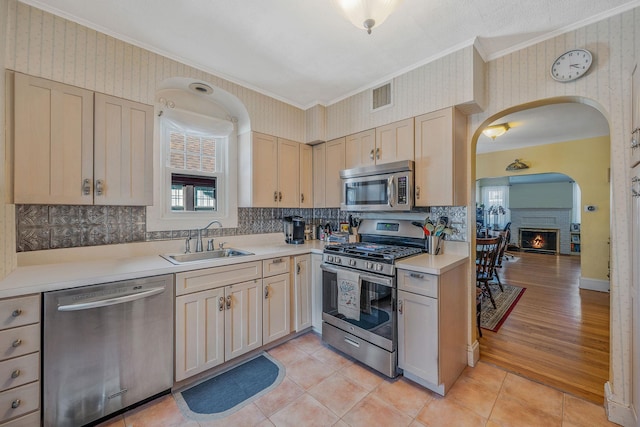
[{"x1": 14, "y1": 73, "x2": 153, "y2": 205}]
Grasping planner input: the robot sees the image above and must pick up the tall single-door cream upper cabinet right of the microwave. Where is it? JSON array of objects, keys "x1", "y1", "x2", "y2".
[{"x1": 414, "y1": 107, "x2": 467, "y2": 206}]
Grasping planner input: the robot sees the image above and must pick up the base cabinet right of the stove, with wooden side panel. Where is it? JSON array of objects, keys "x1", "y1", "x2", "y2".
[{"x1": 398, "y1": 265, "x2": 467, "y2": 396}]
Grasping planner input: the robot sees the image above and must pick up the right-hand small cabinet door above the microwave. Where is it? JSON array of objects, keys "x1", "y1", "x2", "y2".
[{"x1": 375, "y1": 117, "x2": 415, "y2": 164}]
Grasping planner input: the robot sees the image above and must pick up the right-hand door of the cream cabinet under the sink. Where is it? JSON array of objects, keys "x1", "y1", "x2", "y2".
[{"x1": 224, "y1": 280, "x2": 262, "y2": 360}]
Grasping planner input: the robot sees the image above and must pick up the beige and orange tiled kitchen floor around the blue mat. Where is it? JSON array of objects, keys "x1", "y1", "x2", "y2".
[{"x1": 99, "y1": 333, "x2": 615, "y2": 427}]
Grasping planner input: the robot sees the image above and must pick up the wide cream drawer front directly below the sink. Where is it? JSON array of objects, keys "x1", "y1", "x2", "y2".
[{"x1": 176, "y1": 261, "x2": 262, "y2": 295}]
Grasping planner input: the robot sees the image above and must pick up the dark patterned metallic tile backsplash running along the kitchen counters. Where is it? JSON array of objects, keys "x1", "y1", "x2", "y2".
[{"x1": 16, "y1": 205, "x2": 467, "y2": 252}]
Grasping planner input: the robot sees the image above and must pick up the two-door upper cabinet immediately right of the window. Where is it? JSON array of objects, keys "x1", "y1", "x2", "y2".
[{"x1": 239, "y1": 132, "x2": 304, "y2": 208}]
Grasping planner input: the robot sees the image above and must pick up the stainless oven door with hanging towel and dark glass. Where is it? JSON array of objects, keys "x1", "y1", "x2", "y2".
[{"x1": 321, "y1": 264, "x2": 397, "y2": 352}]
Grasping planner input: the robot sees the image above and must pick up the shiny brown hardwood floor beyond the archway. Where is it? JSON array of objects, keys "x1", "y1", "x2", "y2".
[{"x1": 479, "y1": 252, "x2": 609, "y2": 404}]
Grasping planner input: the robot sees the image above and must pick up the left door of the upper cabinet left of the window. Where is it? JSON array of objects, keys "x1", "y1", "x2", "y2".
[{"x1": 14, "y1": 73, "x2": 93, "y2": 205}]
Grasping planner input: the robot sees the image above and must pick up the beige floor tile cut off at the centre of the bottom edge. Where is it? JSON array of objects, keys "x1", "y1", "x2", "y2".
[{"x1": 269, "y1": 393, "x2": 338, "y2": 427}]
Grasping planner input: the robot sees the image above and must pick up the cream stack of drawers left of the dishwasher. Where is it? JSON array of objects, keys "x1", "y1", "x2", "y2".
[{"x1": 0, "y1": 295, "x2": 40, "y2": 426}]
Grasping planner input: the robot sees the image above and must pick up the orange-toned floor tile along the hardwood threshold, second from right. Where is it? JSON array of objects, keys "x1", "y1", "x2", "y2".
[{"x1": 490, "y1": 374, "x2": 563, "y2": 427}]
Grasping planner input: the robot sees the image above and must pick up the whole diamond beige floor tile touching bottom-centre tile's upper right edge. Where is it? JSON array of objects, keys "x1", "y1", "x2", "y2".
[{"x1": 307, "y1": 374, "x2": 369, "y2": 417}]
